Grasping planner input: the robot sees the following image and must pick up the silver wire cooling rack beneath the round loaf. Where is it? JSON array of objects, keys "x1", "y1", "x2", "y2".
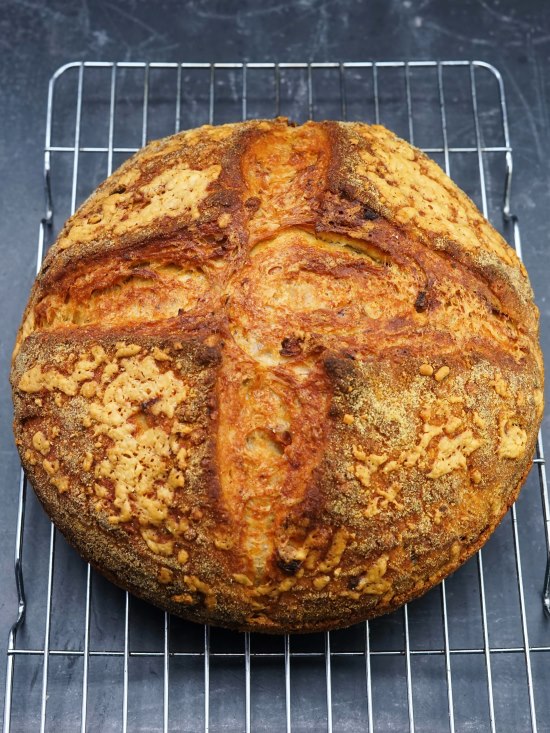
[{"x1": 4, "y1": 61, "x2": 550, "y2": 733}]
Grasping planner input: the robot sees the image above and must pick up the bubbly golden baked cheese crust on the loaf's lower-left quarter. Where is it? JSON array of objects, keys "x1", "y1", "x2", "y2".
[{"x1": 12, "y1": 341, "x2": 218, "y2": 584}]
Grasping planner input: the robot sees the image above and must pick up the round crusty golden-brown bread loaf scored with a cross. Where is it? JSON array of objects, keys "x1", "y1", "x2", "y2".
[{"x1": 12, "y1": 119, "x2": 543, "y2": 633}]
